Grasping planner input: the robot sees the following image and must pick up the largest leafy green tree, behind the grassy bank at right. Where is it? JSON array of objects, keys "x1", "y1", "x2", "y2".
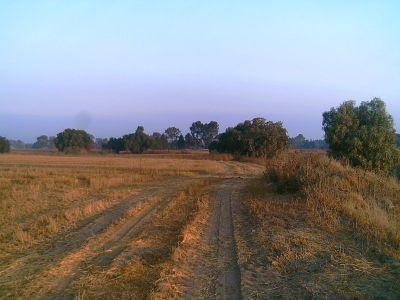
[{"x1": 322, "y1": 98, "x2": 399, "y2": 173}]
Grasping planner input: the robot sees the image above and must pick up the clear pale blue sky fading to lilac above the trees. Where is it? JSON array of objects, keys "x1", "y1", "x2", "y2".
[{"x1": 0, "y1": 0, "x2": 400, "y2": 142}]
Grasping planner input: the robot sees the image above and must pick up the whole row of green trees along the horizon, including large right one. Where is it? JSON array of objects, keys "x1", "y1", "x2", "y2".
[{"x1": 0, "y1": 98, "x2": 400, "y2": 178}]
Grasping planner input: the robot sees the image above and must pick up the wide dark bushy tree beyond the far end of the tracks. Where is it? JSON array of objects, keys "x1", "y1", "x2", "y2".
[{"x1": 209, "y1": 118, "x2": 289, "y2": 157}]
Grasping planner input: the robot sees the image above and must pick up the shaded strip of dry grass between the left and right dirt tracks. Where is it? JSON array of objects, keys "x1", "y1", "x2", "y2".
[{"x1": 75, "y1": 181, "x2": 209, "y2": 299}]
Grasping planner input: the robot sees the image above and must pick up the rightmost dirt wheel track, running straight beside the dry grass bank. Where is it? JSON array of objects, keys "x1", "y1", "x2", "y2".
[{"x1": 180, "y1": 179, "x2": 243, "y2": 299}]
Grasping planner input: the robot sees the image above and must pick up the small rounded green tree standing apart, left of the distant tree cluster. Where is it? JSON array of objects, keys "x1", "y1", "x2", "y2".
[{"x1": 54, "y1": 128, "x2": 93, "y2": 152}]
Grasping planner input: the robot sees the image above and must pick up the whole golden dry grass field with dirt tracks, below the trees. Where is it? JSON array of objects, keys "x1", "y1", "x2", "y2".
[{"x1": 0, "y1": 152, "x2": 400, "y2": 299}]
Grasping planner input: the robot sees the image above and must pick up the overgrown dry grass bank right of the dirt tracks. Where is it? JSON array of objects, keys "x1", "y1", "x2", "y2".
[{"x1": 238, "y1": 151, "x2": 400, "y2": 299}]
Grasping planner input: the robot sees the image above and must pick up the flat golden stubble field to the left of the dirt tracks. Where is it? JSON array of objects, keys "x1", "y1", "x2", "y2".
[{"x1": 0, "y1": 154, "x2": 225, "y2": 257}]
